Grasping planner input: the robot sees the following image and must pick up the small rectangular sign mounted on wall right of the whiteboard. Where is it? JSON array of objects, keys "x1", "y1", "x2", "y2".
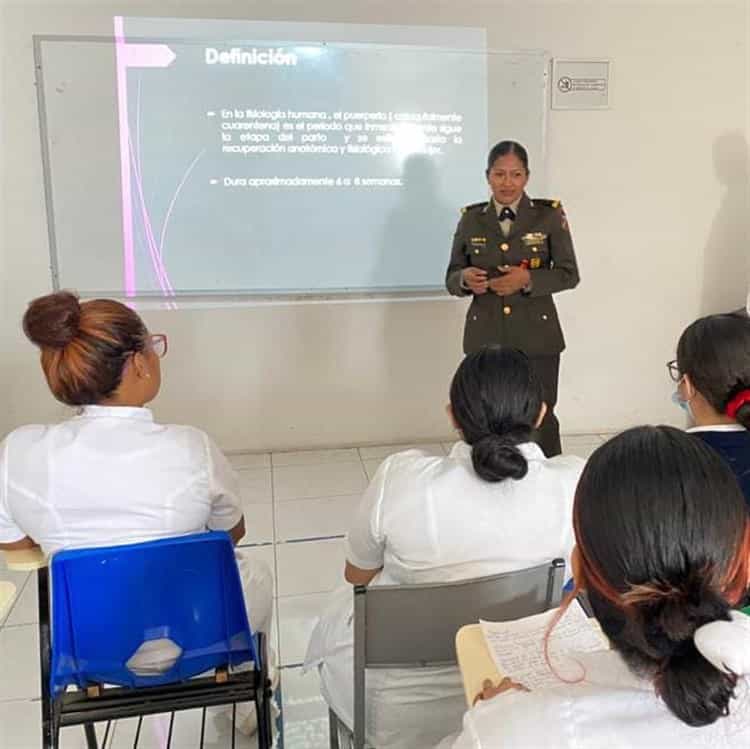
[{"x1": 551, "y1": 58, "x2": 612, "y2": 109}]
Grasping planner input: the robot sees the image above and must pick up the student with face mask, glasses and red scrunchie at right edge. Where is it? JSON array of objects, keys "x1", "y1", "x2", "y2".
[{"x1": 667, "y1": 314, "x2": 750, "y2": 505}]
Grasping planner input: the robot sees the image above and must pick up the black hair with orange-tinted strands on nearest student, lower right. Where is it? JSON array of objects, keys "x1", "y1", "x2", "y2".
[{"x1": 573, "y1": 426, "x2": 750, "y2": 726}]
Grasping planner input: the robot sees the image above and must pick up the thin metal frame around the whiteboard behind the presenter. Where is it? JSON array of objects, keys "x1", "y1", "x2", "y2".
[{"x1": 32, "y1": 34, "x2": 553, "y2": 309}]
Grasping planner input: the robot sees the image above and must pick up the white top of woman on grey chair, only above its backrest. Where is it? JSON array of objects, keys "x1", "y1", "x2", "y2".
[{"x1": 346, "y1": 442, "x2": 584, "y2": 585}]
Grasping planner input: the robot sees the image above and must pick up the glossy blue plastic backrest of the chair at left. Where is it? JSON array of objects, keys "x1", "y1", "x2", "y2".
[{"x1": 49, "y1": 532, "x2": 258, "y2": 696}]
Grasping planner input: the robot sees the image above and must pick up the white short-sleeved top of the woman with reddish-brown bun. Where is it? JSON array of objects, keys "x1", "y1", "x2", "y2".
[{"x1": 0, "y1": 406, "x2": 242, "y2": 554}]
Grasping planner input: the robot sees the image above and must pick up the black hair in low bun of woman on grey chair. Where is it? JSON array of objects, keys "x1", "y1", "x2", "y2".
[{"x1": 450, "y1": 345, "x2": 542, "y2": 481}]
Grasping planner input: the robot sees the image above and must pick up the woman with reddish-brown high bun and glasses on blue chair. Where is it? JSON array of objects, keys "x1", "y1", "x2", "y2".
[{"x1": 0, "y1": 292, "x2": 273, "y2": 672}]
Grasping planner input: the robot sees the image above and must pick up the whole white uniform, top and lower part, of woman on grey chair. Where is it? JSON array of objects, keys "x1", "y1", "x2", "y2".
[{"x1": 305, "y1": 442, "x2": 584, "y2": 749}]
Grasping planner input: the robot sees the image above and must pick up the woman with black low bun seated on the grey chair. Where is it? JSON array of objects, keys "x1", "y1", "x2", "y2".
[{"x1": 306, "y1": 346, "x2": 584, "y2": 749}]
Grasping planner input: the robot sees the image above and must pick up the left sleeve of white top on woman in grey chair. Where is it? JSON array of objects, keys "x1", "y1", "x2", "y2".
[{"x1": 346, "y1": 458, "x2": 391, "y2": 570}]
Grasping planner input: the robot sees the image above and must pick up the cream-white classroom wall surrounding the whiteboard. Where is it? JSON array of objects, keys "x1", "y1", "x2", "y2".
[{"x1": 0, "y1": 0, "x2": 749, "y2": 449}]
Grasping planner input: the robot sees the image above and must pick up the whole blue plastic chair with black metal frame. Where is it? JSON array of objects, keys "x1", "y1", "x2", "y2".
[{"x1": 39, "y1": 532, "x2": 271, "y2": 749}]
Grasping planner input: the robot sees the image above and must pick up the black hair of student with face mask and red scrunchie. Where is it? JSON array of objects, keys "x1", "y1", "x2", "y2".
[{"x1": 677, "y1": 313, "x2": 750, "y2": 429}]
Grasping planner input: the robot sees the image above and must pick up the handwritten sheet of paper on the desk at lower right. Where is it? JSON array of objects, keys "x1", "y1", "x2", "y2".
[{"x1": 480, "y1": 601, "x2": 609, "y2": 689}]
